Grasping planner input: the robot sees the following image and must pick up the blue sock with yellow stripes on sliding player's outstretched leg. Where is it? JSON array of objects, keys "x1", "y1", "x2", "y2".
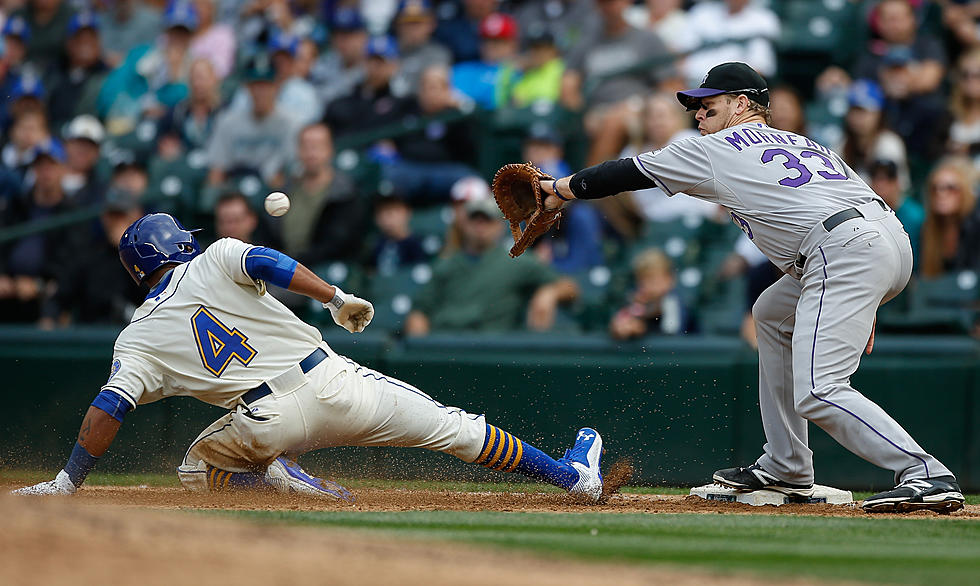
[{"x1": 474, "y1": 425, "x2": 578, "y2": 490}]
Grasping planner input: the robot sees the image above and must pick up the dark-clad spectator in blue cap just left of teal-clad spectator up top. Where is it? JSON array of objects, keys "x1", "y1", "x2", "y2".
[{"x1": 48, "y1": 12, "x2": 109, "y2": 128}]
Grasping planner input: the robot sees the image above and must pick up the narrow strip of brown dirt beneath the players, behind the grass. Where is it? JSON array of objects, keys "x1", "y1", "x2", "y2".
[{"x1": 0, "y1": 482, "x2": 980, "y2": 520}]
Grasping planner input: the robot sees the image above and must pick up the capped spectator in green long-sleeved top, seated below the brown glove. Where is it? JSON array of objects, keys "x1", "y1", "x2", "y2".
[{"x1": 405, "y1": 198, "x2": 578, "y2": 336}]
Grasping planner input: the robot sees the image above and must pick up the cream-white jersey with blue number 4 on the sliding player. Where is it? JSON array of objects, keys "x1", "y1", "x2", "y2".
[{"x1": 102, "y1": 238, "x2": 323, "y2": 408}]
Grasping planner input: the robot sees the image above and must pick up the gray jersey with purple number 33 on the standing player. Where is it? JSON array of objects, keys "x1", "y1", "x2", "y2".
[{"x1": 633, "y1": 122, "x2": 877, "y2": 274}]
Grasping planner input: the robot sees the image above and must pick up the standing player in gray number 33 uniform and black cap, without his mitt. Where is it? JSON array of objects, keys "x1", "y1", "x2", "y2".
[{"x1": 541, "y1": 63, "x2": 963, "y2": 512}]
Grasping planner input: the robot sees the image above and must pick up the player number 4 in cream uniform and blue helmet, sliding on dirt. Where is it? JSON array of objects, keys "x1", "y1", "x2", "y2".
[{"x1": 15, "y1": 214, "x2": 602, "y2": 502}]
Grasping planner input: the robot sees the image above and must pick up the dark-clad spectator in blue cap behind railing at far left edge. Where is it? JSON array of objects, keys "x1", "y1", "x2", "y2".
[{"x1": 0, "y1": 141, "x2": 71, "y2": 323}]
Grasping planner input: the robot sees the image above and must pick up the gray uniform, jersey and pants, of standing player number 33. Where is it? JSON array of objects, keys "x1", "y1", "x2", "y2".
[{"x1": 633, "y1": 123, "x2": 950, "y2": 485}]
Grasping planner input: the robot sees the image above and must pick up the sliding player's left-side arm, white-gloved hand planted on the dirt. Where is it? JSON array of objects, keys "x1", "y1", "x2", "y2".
[{"x1": 13, "y1": 391, "x2": 128, "y2": 495}]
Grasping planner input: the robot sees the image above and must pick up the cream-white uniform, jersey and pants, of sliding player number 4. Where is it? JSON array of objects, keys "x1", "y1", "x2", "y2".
[{"x1": 103, "y1": 239, "x2": 523, "y2": 489}]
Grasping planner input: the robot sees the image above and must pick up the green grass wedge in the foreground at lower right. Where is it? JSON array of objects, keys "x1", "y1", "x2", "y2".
[{"x1": 214, "y1": 511, "x2": 980, "y2": 584}]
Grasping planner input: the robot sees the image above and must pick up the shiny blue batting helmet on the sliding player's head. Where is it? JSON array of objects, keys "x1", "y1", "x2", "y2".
[{"x1": 119, "y1": 214, "x2": 201, "y2": 284}]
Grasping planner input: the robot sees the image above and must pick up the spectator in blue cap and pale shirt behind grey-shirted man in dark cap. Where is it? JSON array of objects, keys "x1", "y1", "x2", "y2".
[{"x1": 229, "y1": 32, "x2": 323, "y2": 126}]
